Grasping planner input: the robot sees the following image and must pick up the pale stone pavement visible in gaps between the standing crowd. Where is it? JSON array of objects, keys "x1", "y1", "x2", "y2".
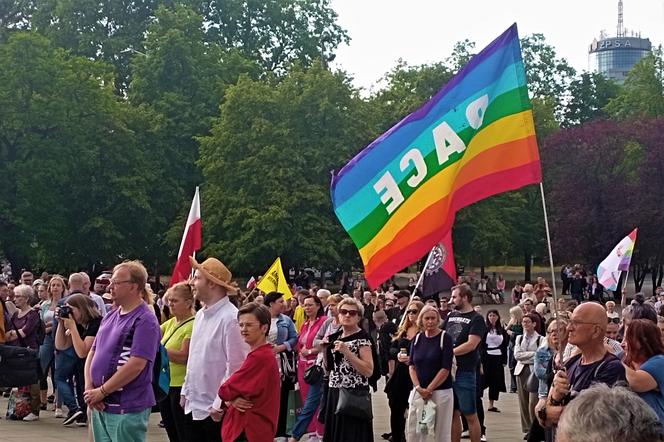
[{"x1": 0, "y1": 304, "x2": 523, "y2": 442}]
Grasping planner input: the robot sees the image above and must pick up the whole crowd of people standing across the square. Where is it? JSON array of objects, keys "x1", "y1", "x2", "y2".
[{"x1": 0, "y1": 258, "x2": 664, "y2": 442}]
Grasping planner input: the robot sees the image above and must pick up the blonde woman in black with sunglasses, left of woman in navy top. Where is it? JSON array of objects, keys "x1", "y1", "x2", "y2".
[{"x1": 385, "y1": 301, "x2": 424, "y2": 442}]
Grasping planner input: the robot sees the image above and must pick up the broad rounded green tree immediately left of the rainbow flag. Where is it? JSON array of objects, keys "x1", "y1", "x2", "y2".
[{"x1": 199, "y1": 62, "x2": 373, "y2": 272}]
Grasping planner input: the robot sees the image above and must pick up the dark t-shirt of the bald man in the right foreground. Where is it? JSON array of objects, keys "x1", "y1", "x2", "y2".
[{"x1": 565, "y1": 352, "x2": 626, "y2": 398}]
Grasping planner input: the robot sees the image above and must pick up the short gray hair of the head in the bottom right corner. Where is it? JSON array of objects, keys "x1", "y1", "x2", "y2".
[{"x1": 558, "y1": 384, "x2": 664, "y2": 442}]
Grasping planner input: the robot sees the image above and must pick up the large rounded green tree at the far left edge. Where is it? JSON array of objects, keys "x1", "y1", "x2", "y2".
[{"x1": 0, "y1": 33, "x2": 158, "y2": 271}]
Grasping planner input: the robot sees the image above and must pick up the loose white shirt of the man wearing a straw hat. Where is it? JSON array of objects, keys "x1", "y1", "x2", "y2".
[{"x1": 181, "y1": 297, "x2": 249, "y2": 421}]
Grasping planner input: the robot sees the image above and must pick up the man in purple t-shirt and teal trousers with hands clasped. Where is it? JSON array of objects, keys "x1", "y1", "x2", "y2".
[{"x1": 85, "y1": 261, "x2": 161, "y2": 442}]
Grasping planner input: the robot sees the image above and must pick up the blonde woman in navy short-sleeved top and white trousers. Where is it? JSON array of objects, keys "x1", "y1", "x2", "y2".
[{"x1": 408, "y1": 305, "x2": 454, "y2": 442}]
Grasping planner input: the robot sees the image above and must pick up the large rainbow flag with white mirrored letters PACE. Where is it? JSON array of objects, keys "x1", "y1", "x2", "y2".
[{"x1": 331, "y1": 24, "x2": 542, "y2": 287}]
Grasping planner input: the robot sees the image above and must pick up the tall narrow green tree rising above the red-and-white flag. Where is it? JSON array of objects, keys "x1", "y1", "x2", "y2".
[{"x1": 129, "y1": 5, "x2": 258, "y2": 253}]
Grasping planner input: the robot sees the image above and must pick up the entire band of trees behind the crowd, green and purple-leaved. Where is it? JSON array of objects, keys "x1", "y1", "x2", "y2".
[{"x1": 0, "y1": 6, "x2": 664, "y2": 286}]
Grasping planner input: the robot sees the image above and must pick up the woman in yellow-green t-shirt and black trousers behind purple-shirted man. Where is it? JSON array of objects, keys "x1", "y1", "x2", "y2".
[{"x1": 159, "y1": 282, "x2": 195, "y2": 442}]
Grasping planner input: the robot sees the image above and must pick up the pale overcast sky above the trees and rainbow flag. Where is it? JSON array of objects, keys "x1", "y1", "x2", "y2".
[{"x1": 332, "y1": 0, "x2": 664, "y2": 89}]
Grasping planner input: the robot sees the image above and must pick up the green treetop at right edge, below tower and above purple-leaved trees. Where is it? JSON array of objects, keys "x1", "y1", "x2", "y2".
[{"x1": 605, "y1": 47, "x2": 664, "y2": 119}]
